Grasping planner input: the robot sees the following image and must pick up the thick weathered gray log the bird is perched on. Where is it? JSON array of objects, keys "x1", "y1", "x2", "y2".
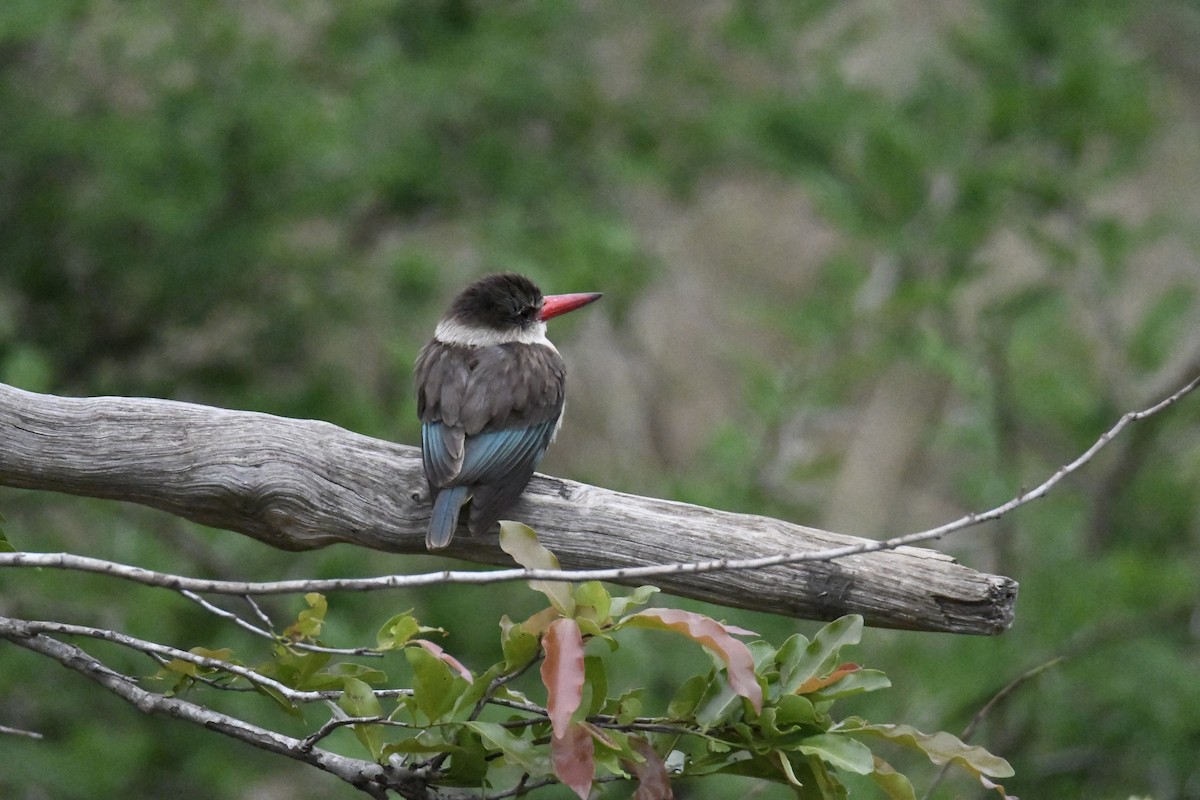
[{"x1": 0, "y1": 384, "x2": 1016, "y2": 634}]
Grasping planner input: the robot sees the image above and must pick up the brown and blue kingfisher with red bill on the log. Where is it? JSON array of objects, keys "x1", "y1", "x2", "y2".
[{"x1": 414, "y1": 272, "x2": 601, "y2": 551}]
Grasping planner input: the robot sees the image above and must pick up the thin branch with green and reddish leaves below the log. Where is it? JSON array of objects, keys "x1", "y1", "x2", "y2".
[{"x1": 0, "y1": 523, "x2": 1012, "y2": 800}]
